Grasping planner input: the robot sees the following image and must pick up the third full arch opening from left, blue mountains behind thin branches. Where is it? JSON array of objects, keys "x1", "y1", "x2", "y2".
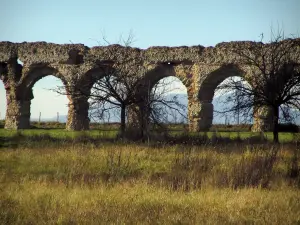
[{"x1": 142, "y1": 62, "x2": 188, "y2": 129}]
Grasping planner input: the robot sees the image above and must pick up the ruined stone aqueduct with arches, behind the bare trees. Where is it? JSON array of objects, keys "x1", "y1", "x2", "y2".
[{"x1": 0, "y1": 42, "x2": 298, "y2": 131}]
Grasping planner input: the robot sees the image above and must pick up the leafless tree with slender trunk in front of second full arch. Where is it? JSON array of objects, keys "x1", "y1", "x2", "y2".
[{"x1": 88, "y1": 33, "x2": 144, "y2": 137}]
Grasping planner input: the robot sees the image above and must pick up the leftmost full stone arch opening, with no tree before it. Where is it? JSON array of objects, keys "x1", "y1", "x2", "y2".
[{"x1": 19, "y1": 65, "x2": 69, "y2": 128}]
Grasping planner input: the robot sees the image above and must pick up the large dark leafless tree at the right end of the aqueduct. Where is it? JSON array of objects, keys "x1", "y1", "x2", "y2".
[{"x1": 218, "y1": 30, "x2": 300, "y2": 143}]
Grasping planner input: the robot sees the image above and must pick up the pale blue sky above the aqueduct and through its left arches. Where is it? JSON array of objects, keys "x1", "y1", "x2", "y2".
[{"x1": 0, "y1": 0, "x2": 300, "y2": 119}]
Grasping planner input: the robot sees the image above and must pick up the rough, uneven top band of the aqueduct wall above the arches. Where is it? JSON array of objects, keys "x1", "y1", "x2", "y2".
[{"x1": 0, "y1": 38, "x2": 300, "y2": 65}]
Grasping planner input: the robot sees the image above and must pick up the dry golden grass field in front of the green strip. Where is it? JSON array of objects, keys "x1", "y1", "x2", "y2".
[{"x1": 0, "y1": 144, "x2": 300, "y2": 224}]
